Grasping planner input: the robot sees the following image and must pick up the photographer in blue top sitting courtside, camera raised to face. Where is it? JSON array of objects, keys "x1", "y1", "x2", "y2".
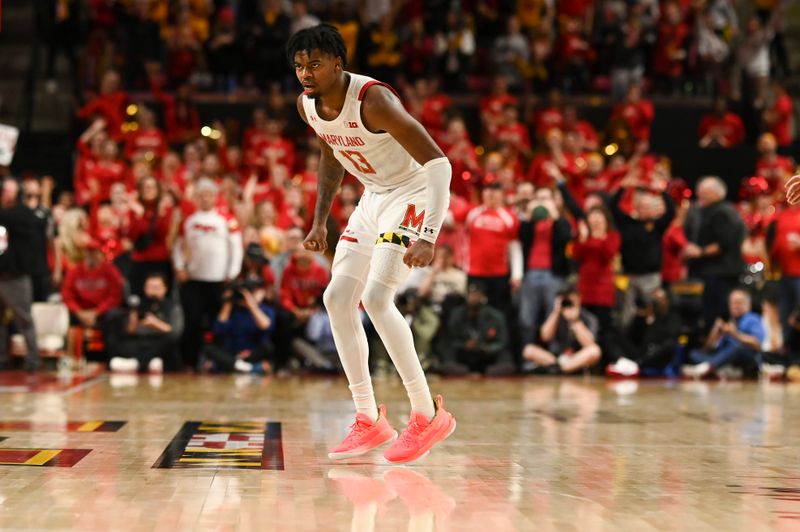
[{"x1": 200, "y1": 279, "x2": 275, "y2": 375}]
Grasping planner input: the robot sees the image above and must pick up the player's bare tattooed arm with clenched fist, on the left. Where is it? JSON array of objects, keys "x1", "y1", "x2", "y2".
[{"x1": 297, "y1": 95, "x2": 344, "y2": 252}]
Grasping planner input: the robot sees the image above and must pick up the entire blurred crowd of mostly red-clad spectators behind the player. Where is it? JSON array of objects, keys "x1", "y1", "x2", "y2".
[{"x1": 6, "y1": 0, "x2": 800, "y2": 376}]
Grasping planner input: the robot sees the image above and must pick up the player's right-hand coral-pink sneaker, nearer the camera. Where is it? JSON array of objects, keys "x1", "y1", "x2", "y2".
[{"x1": 383, "y1": 395, "x2": 456, "y2": 464}]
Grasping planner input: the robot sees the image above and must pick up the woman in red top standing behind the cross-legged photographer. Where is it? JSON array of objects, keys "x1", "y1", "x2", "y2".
[{"x1": 572, "y1": 206, "x2": 620, "y2": 332}]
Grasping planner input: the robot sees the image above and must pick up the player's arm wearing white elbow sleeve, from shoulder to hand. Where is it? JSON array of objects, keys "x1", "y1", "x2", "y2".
[{"x1": 361, "y1": 85, "x2": 453, "y2": 266}]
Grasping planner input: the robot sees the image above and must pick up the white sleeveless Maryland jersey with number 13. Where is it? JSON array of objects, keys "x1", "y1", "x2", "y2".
[{"x1": 303, "y1": 73, "x2": 425, "y2": 192}]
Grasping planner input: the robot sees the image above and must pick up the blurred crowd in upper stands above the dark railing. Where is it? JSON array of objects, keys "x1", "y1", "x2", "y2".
[{"x1": 50, "y1": 0, "x2": 790, "y2": 100}]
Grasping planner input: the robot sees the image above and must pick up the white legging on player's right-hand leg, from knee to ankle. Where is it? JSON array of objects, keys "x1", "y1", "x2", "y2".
[{"x1": 361, "y1": 268, "x2": 436, "y2": 419}]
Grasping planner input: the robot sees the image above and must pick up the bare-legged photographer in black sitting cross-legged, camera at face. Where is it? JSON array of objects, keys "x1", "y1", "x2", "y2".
[{"x1": 522, "y1": 286, "x2": 601, "y2": 375}]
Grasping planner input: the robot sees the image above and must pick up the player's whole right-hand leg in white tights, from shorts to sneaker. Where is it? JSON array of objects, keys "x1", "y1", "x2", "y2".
[{"x1": 361, "y1": 245, "x2": 435, "y2": 419}]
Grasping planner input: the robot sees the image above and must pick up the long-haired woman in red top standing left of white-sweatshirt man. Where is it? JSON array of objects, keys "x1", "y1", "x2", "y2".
[{"x1": 128, "y1": 176, "x2": 173, "y2": 296}]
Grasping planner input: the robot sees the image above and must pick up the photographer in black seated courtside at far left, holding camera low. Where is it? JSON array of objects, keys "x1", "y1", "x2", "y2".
[{"x1": 106, "y1": 272, "x2": 183, "y2": 373}]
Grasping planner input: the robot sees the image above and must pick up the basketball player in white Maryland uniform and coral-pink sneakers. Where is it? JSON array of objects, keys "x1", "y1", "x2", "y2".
[{"x1": 287, "y1": 24, "x2": 456, "y2": 463}]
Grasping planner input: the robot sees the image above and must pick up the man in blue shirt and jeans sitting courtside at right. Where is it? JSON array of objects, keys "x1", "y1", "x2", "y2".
[{"x1": 683, "y1": 288, "x2": 764, "y2": 378}]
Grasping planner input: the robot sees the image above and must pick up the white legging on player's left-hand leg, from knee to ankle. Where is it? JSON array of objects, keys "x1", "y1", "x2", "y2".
[{"x1": 325, "y1": 272, "x2": 378, "y2": 421}]
